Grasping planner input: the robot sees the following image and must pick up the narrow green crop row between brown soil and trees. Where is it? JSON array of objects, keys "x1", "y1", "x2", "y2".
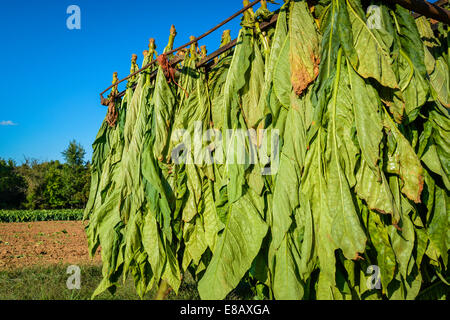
[{"x1": 0, "y1": 209, "x2": 83, "y2": 222}]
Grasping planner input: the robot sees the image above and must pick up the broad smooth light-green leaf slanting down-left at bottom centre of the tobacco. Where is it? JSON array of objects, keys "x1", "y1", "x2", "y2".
[{"x1": 198, "y1": 195, "x2": 268, "y2": 300}]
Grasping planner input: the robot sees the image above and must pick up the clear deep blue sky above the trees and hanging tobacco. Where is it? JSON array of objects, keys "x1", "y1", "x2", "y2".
[{"x1": 0, "y1": 0, "x2": 282, "y2": 163}]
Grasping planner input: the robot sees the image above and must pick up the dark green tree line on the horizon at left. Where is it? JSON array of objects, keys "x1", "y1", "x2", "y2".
[{"x1": 0, "y1": 140, "x2": 91, "y2": 210}]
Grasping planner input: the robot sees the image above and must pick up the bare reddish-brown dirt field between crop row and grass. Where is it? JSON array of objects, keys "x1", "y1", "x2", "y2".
[{"x1": 0, "y1": 221, "x2": 101, "y2": 270}]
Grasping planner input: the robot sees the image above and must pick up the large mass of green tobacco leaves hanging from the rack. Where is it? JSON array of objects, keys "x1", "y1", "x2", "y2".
[{"x1": 85, "y1": 0, "x2": 450, "y2": 299}]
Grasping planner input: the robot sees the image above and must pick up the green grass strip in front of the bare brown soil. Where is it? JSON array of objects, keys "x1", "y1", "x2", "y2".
[{"x1": 0, "y1": 265, "x2": 251, "y2": 300}]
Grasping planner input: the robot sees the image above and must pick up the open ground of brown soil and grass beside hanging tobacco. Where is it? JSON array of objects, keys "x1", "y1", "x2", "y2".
[{"x1": 0, "y1": 221, "x2": 248, "y2": 300}]
